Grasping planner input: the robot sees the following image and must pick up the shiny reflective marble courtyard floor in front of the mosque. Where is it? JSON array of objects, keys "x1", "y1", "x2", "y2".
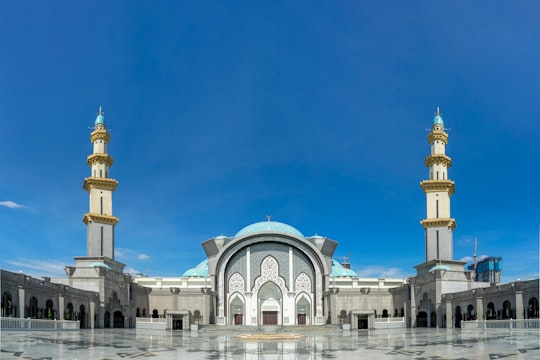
[{"x1": 0, "y1": 328, "x2": 540, "y2": 360}]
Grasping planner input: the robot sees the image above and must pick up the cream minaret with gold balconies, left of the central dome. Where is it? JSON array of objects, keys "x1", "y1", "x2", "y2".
[{"x1": 83, "y1": 106, "x2": 119, "y2": 260}]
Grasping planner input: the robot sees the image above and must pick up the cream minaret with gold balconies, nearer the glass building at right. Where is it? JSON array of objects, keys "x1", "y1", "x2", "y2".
[{"x1": 420, "y1": 107, "x2": 456, "y2": 262}]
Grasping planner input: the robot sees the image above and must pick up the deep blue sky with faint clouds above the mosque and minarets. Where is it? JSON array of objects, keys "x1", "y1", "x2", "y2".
[{"x1": 0, "y1": 1, "x2": 540, "y2": 281}]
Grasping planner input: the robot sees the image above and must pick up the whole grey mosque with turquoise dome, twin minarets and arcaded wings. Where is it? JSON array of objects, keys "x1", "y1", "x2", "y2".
[{"x1": 1, "y1": 108, "x2": 538, "y2": 330}]
